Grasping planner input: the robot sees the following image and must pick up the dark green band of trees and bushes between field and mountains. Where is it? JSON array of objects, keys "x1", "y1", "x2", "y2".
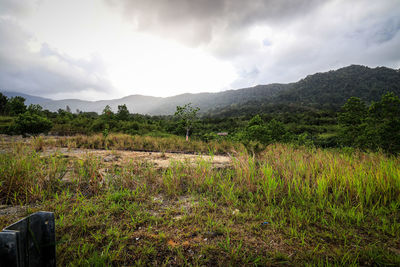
[{"x1": 0, "y1": 93, "x2": 400, "y2": 153}]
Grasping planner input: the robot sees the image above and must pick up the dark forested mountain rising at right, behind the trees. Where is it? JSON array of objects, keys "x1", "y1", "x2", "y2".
[{"x1": 208, "y1": 65, "x2": 400, "y2": 117}]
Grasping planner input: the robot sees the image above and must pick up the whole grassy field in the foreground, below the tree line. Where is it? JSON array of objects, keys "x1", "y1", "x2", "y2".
[{"x1": 0, "y1": 135, "x2": 400, "y2": 266}]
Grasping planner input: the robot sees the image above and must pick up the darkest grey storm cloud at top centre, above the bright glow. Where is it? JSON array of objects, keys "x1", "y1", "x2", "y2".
[{"x1": 106, "y1": 0, "x2": 324, "y2": 45}]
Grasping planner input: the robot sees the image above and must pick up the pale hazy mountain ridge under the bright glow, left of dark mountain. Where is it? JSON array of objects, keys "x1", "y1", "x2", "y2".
[{"x1": 0, "y1": 84, "x2": 289, "y2": 115}]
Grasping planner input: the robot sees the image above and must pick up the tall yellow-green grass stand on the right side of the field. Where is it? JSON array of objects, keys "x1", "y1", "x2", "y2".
[{"x1": 156, "y1": 145, "x2": 400, "y2": 208}]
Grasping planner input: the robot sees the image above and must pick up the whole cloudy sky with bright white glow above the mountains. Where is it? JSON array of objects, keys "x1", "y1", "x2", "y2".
[{"x1": 0, "y1": 0, "x2": 400, "y2": 100}]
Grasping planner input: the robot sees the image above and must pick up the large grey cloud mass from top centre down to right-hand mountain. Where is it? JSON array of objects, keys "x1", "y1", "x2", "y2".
[{"x1": 107, "y1": 0, "x2": 400, "y2": 88}]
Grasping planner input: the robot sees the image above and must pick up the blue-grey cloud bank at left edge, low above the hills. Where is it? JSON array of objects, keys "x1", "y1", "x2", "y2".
[{"x1": 0, "y1": 18, "x2": 112, "y2": 100}]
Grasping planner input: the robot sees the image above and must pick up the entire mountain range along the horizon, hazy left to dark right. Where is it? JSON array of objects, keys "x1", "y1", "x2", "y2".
[{"x1": 4, "y1": 65, "x2": 400, "y2": 116}]
